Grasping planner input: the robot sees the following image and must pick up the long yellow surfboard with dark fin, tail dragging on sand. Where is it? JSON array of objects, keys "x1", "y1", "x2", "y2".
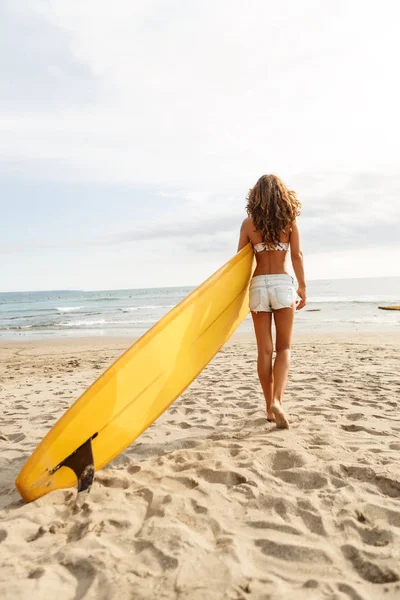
[{"x1": 16, "y1": 244, "x2": 253, "y2": 501}]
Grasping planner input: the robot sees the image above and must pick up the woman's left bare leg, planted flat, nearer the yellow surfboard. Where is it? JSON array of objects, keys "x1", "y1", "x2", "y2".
[{"x1": 251, "y1": 312, "x2": 274, "y2": 420}]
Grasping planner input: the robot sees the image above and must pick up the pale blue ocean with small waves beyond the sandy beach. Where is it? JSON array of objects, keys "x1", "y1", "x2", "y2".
[{"x1": 0, "y1": 277, "x2": 400, "y2": 340}]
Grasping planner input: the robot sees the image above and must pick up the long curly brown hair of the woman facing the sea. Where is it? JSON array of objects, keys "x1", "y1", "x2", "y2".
[{"x1": 246, "y1": 175, "x2": 301, "y2": 245}]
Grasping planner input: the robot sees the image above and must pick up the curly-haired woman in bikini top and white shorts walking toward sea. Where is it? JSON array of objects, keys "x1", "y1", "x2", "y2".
[{"x1": 238, "y1": 175, "x2": 306, "y2": 428}]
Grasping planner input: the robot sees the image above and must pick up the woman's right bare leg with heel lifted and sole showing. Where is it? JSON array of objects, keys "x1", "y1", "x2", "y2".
[{"x1": 271, "y1": 305, "x2": 295, "y2": 428}]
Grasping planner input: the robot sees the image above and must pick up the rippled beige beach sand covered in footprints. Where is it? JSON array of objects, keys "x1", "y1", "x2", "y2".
[{"x1": 0, "y1": 334, "x2": 400, "y2": 600}]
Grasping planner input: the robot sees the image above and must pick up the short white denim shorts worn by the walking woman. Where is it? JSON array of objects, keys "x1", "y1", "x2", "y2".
[{"x1": 249, "y1": 273, "x2": 298, "y2": 312}]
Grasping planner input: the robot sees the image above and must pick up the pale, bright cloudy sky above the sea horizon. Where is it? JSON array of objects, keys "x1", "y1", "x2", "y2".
[{"x1": 0, "y1": 0, "x2": 400, "y2": 292}]
